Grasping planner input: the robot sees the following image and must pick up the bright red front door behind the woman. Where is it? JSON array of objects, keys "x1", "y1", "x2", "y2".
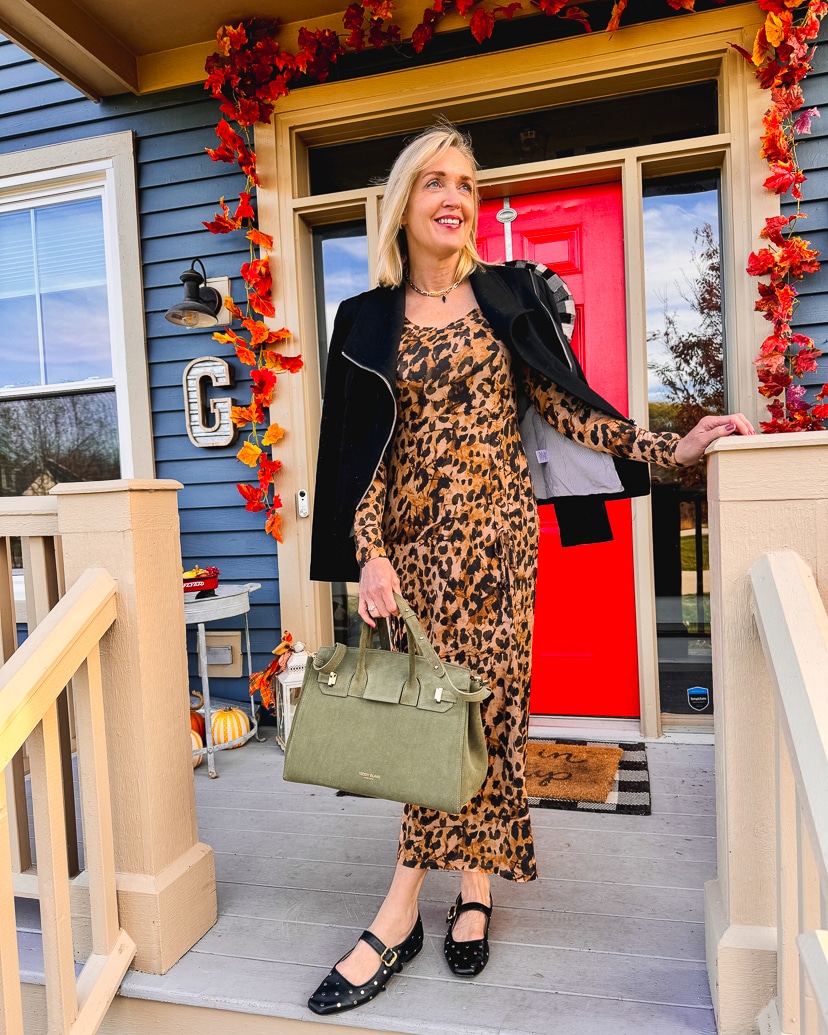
[{"x1": 471, "y1": 183, "x2": 640, "y2": 716}]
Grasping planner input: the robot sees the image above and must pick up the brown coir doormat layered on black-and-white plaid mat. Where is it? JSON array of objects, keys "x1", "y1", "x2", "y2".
[{"x1": 526, "y1": 738, "x2": 651, "y2": 816}]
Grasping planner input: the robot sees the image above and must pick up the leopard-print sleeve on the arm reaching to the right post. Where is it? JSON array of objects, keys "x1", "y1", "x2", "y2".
[{"x1": 524, "y1": 371, "x2": 681, "y2": 467}]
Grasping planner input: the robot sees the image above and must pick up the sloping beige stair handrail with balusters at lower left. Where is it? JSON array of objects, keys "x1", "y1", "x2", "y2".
[{"x1": 0, "y1": 568, "x2": 136, "y2": 1035}]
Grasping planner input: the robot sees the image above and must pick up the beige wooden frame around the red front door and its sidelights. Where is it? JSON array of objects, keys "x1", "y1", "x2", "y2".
[{"x1": 256, "y1": 3, "x2": 779, "y2": 737}]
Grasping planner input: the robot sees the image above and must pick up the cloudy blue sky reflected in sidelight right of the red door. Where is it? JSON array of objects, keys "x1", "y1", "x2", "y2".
[{"x1": 644, "y1": 190, "x2": 718, "y2": 403}]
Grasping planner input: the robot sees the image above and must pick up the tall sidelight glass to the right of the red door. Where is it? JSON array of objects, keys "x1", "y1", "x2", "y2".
[{"x1": 644, "y1": 173, "x2": 725, "y2": 714}]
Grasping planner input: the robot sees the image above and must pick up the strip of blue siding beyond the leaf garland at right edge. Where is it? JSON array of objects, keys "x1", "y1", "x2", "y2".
[{"x1": 782, "y1": 25, "x2": 828, "y2": 396}]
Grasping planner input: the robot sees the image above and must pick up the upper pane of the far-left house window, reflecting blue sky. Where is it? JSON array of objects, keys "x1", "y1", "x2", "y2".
[{"x1": 0, "y1": 198, "x2": 112, "y2": 387}]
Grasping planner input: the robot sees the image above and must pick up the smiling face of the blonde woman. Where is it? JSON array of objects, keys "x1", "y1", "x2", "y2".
[{"x1": 401, "y1": 147, "x2": 477, "y2": 262}]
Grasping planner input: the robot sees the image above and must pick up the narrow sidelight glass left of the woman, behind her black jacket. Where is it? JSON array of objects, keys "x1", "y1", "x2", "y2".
[{"x1": 314, "y1": 221, "x2": 371, "y2": 646}]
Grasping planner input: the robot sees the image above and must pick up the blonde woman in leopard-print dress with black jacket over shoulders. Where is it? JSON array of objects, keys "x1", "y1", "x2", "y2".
[{"x1": 308, "y1": 124, "x2": 753, "y2": 1013}]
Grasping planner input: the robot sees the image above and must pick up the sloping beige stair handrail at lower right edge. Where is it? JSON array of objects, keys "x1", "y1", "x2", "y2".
[{"x1": 750, "y1": 551, "x2": 828, "y2": 1035}]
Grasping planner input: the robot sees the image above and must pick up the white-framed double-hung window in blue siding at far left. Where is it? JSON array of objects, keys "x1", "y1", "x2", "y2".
[{"x1": 0, "y1": 183, "x2": 120, "y2": 496}]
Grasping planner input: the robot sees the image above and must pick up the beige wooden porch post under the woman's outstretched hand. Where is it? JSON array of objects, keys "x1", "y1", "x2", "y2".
[{"x1": 705, "y1": 432, "x2": 828, "y2": 1035}]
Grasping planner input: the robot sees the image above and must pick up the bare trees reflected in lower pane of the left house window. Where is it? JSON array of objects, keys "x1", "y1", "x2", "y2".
[{"x1": 0, "y1": 391, "x2": 120, "y2": 496}]
